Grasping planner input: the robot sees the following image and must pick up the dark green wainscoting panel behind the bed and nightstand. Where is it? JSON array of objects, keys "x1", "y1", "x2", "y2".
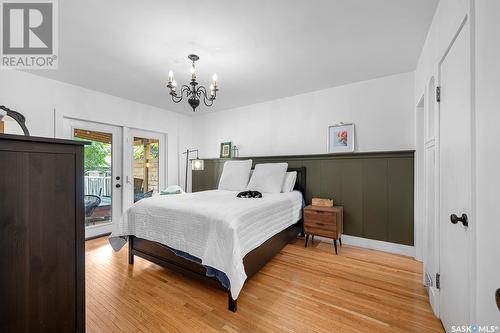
[{"x1": 193, "y1": 151, "x2": 414, "y2": 245}]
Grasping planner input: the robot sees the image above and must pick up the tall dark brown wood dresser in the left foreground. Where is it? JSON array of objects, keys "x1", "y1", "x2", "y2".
[{"x1": 0, "y1": 134, "x2": 85, "y2": 332}]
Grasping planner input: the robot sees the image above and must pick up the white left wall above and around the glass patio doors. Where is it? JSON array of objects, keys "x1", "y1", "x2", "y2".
[{"x1": 0, "y1": 70, "x2": 192, "y2": 184}]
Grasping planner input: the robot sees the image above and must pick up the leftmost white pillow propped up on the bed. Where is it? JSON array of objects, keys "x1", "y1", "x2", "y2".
[{"x1": 219, "y1": 160, "x2": 252, "y2": 191}]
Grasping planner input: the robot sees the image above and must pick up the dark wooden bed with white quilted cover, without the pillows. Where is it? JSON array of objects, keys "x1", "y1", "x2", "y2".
[{"x1": 110, "y1": 167, "x2": 306, "y2": 312}]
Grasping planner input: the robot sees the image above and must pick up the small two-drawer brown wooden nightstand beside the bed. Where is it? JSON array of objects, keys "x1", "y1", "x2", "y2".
[{"x1": 304, "y1": 205, "x2": 344, "y2": 254}]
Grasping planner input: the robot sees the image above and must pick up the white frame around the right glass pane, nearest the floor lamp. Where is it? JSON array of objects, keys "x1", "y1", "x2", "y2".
[{"x1": 123, "y1": 127, "x2": 168, "y2": 211}]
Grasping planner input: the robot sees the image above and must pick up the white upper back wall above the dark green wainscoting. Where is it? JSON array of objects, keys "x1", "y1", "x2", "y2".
[{"x1": 193, "y1": 73, "x2": 414, "y2": 157}]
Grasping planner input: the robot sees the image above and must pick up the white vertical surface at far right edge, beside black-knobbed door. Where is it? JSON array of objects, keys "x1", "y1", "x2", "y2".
[{"x1": 475, "y1": 0, "x2": 500, "y2": 326}]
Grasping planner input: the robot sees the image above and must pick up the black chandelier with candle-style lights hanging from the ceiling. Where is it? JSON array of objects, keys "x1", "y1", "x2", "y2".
[{"x1": 167, "y1": 54, "x2": 219, "y2": 112}]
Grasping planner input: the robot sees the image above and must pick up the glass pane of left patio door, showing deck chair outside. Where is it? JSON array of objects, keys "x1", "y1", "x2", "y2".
[{"x1": 73, "y1": 128, "x2": 113, "y2": 227}]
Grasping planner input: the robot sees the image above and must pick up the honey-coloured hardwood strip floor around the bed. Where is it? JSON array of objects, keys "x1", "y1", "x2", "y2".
[{"x1": 86, "y1": 238, "x2": 443, "y2": 332}]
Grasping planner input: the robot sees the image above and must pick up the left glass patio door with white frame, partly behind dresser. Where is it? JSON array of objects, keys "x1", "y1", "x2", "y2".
[{"x1": 63, "y1": 118, "x2": 123, "y2": 238}]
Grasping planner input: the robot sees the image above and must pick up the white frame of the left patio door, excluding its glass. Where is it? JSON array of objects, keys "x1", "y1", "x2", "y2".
[{"x1": 62, "y1": 117, "x2": 123, "y2": 239}]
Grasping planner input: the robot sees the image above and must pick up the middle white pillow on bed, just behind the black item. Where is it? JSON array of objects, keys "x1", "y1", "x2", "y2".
[{"x1": 247, "y1": 163, "x2": 288, "y2": 193}]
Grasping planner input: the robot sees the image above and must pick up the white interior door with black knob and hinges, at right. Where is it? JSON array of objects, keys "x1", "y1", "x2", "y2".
[{"x1": 439, "y1": 20, "x2": 474, "y2": 331}]
